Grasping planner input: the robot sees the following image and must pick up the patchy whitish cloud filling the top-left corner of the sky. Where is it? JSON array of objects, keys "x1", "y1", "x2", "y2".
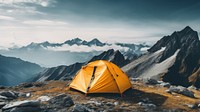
[{"x1": 0, "y1": 0, "x2": 56, "y2": 17}]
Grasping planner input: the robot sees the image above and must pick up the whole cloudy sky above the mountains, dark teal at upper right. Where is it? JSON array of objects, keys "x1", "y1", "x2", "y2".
[{"x1": 0, "y1": 0, "x2": 200, "y2": 47}]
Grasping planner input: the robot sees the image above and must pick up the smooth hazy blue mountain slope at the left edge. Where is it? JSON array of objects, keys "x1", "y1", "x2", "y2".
[{"x1": 0, "y1": 55, "x2": 43, "y2": 86}]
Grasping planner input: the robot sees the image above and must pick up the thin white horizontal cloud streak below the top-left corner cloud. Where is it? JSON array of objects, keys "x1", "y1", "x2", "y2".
[{"x1": 23, "y1": 20, "x2": 67, "y2": 26}]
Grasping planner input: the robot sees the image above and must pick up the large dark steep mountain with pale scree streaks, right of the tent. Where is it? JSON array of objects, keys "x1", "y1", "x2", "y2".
[{"x1": 123, "y1": 26, "x2": 200, "y2": 87}]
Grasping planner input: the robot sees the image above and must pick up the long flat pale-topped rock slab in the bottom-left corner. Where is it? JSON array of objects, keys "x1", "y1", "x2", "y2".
[{"x1": 2, "y1": 100, "x2": 40, "y2": 110}]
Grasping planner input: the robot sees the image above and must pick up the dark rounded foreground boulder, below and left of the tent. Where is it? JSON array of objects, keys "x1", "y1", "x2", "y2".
[{"x1": 49, "y1": 94, "x2": 74, "y2": 107}]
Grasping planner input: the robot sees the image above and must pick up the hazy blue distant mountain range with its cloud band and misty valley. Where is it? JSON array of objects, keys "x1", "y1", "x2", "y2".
[{"x1": 0, "y1": 38, "x2": 149, "y2": 67}]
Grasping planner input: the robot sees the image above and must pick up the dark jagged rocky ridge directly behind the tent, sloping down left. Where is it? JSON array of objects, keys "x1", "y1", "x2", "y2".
[{"x1": 32, "y1": 49, "x2": 129, "y2": 82}]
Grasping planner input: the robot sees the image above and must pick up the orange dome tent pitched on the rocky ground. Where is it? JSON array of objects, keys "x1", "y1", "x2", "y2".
[{"x1": 70, "y1": 60, "x2": 132, "y2": 94}]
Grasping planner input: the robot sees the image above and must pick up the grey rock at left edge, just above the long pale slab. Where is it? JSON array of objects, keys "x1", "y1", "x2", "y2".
[{"x1": 0, "y1": 91, "x2": 18, "y2": 99}]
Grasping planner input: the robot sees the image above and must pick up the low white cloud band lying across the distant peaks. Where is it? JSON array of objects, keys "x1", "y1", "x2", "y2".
[{"x1": 45, "y1": 44, "x2": 129, "y2": 52}]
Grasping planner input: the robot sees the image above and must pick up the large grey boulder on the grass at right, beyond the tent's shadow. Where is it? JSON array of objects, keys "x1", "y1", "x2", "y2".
[{"x1": 167, "y1": 86, "x2": 195, "y2": 98}]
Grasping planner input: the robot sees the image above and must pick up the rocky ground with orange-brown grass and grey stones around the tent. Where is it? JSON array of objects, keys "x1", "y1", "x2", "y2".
[{"x1": 0, "y1": 79, "x2": 200, "y2": 112}]
